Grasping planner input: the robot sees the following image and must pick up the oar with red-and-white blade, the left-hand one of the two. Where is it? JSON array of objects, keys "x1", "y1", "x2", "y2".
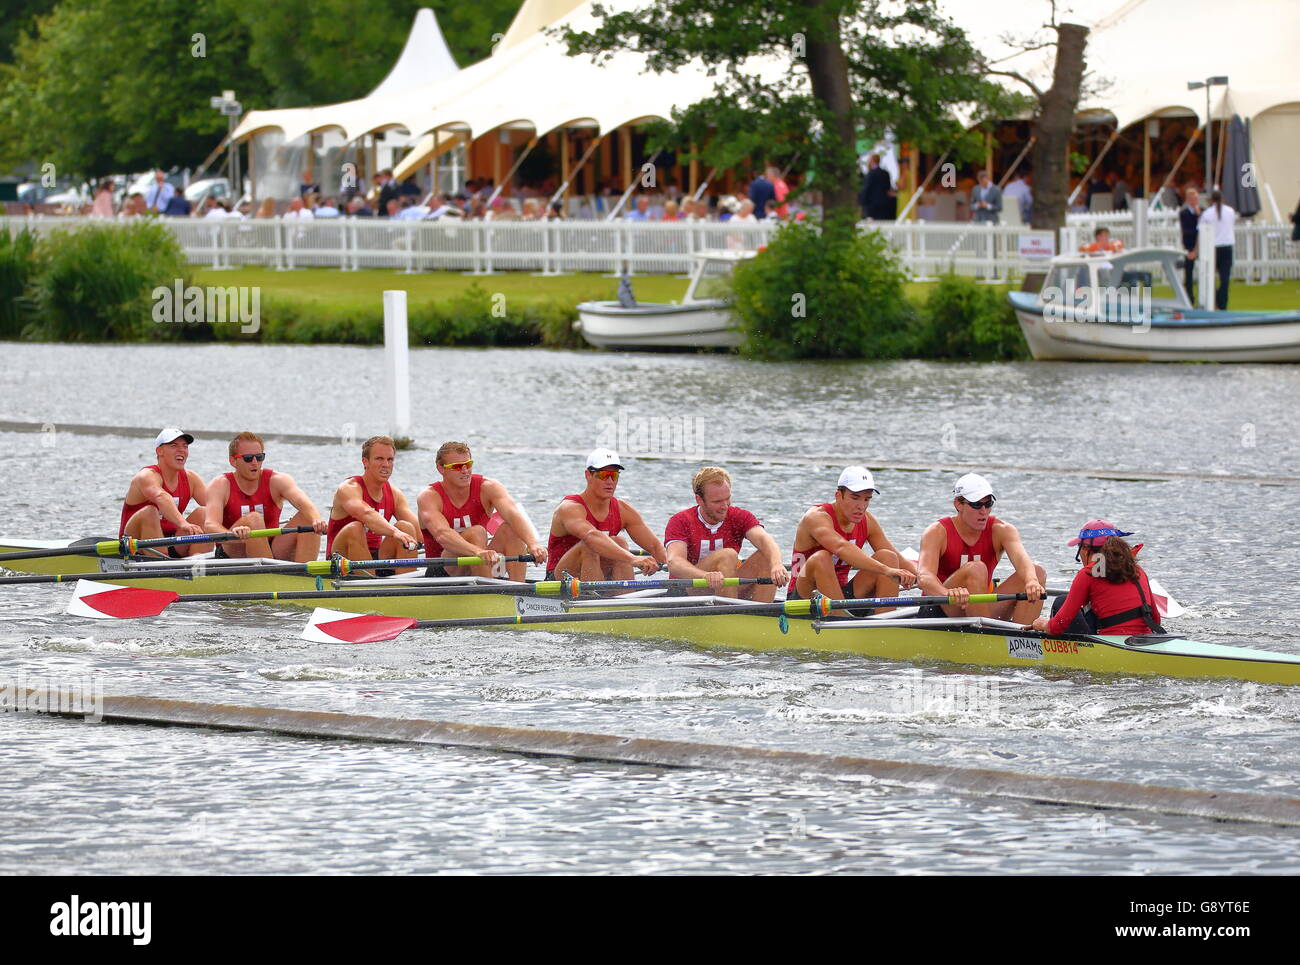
[{"x1": 68, "y1": 576, "x2": 771, "y2": 620}]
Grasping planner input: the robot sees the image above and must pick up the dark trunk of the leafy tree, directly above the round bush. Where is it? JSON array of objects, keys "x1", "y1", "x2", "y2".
[{"x1": 805, "y1": 0, "x2": 858, "y2": 231}]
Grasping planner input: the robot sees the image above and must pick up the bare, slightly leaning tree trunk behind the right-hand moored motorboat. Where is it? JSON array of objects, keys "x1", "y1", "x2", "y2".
[{"x1": 1030, "y1": 23, "x2": 1088, "y2": 230}]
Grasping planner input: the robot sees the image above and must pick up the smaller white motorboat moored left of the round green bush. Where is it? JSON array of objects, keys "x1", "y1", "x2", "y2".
[{"x1": 573, "y1": 251, "x2": 757, "y2": 349}]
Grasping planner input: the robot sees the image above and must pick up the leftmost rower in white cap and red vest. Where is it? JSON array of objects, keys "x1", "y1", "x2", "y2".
[{"x1": 117, "y1": 425, "x2": 209, "y2": 559}]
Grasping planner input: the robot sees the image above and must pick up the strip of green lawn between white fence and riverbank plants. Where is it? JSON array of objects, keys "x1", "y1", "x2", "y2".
[{"x1": 195, "y1": 268, "x2": 1300, "y2": 311}]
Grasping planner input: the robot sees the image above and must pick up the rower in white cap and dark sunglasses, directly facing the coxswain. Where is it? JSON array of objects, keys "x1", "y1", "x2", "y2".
[{"x1": 917, "y1": 472, "x2": 1047, "y2": 624}]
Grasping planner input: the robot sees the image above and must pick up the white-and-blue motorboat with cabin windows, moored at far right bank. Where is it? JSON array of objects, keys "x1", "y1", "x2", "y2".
[{"x1": 1010, "y1": 248, "x2": 1300, "y2": 362}]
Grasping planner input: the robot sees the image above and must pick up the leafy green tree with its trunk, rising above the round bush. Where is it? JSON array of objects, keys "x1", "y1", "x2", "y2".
[{"x1": 564, "y1": 0, "x2": 1018, "y2": 233}]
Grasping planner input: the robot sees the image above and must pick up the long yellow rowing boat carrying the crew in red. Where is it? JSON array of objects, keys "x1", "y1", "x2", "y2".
[{"x1": 0, "y1": 540, "x2": 1300, "y2": 684}]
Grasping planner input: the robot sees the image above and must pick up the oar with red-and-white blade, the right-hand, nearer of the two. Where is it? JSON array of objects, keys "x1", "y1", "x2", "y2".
[{"x1": 303, "y1": 593, "x2": 1026, "y2": 644}]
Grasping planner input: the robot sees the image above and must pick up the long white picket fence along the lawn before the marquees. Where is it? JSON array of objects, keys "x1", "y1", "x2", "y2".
[{"x1": 0, "y1": 212, "x2": 1300, "y2": 284}]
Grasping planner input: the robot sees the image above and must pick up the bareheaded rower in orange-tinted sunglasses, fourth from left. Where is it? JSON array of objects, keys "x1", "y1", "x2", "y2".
[{"x1": 416, "y1": 442, "x2": 546, "y2": 580}]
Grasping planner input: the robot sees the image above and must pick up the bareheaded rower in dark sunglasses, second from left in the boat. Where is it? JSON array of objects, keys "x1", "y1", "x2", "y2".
[{"x1": 203, "y1": 432, "x2": 325, "y2": 563}]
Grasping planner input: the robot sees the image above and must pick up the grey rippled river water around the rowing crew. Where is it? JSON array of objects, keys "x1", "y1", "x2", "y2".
[{"x1": 0, "y1": 345, "x2": 1300, "y2": 874}]
